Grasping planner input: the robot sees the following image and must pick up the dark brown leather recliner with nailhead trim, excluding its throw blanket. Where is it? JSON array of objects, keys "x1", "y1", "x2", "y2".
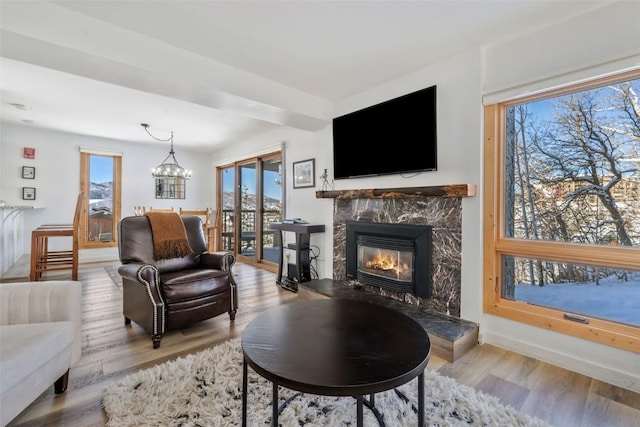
[{"x1": 118, "y1": 216, "x2": 238, "y2": 348}]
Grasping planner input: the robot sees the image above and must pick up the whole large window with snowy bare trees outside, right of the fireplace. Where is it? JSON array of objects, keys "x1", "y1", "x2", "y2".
[{"x1": 484, "y1": 70, "x2": 640, "y2": 353}]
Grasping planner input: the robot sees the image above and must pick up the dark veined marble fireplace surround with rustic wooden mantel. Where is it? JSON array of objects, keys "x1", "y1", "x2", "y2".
[{"x1": 316, "y1": 184, "x2": 476, "y2": 318}]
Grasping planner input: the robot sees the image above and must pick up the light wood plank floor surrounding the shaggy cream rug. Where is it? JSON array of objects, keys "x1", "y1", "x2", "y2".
[{"x1": 10, "y1": 263, "x2": 640, "y2": 427}]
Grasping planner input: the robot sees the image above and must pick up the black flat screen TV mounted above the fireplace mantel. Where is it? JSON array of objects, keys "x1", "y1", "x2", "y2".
[{"x1": 333, "y1": 86, "x2": 438, "y2": 179}]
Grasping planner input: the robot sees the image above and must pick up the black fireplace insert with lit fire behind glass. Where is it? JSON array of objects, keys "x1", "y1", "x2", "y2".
[{"x1": 346, "y1": 221, "x2": 432, "y2": 298}]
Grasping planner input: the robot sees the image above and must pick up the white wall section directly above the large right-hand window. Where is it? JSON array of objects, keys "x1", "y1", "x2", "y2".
[{"x1": 482, "y1": 1, "x2": 640, "y2": 104}]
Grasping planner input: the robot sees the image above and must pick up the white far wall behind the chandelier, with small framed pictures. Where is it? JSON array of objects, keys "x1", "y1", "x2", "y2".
[{"x1": 0, "y1": 124, "x2": 215, "y2": 266}]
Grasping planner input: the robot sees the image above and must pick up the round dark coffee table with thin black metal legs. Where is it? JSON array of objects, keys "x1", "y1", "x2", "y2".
[{"x1": 242, "y1": 299, "x2": 431, "y2": 427}]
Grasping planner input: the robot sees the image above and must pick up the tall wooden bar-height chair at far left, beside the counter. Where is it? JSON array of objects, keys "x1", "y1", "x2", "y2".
[{"x1": 29, "y1": 192, "x2": 84, "y2": 282}]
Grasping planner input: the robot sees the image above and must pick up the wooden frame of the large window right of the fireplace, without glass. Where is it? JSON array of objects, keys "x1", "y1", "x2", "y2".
[{"x1": 483, "y1": 70, "x2": 640, "y2": 353}]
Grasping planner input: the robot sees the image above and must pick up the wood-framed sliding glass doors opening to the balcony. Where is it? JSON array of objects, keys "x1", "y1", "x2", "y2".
[{"x1": 218, "y1": 152, "x2": 284, "y2": 266}]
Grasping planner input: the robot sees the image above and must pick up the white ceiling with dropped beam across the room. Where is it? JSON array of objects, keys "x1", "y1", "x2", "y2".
[{"x1": 0, "y1": 0, "x2": 610, "y2": 151}]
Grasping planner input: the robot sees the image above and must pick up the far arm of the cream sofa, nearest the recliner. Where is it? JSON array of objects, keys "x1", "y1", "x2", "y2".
[{"x1": 0, "y1": 280, "x2": 82, "y2": 365}]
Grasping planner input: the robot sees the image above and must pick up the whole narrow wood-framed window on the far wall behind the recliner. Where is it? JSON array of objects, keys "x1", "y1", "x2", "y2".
[{"x1": 79, "y1": 148, "x2": 122, "y2": 249}]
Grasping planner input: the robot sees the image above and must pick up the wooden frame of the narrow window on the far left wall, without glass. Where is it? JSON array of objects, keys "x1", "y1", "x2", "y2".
[{"x1": 78, "y1": 151, "x2": 122, "y2": 249}]
